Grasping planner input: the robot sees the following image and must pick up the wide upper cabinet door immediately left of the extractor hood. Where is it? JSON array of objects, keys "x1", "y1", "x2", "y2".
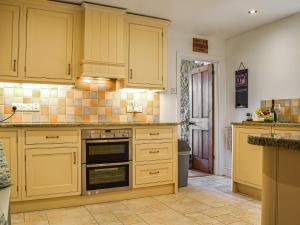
[{"x1": 25, "y1": 8, "x2": 73, "y2": 80}]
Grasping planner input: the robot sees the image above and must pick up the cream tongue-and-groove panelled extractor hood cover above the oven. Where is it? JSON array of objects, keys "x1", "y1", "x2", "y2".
[{"x1": 82, "y1": 3, "x2": 125, "y2": 78}]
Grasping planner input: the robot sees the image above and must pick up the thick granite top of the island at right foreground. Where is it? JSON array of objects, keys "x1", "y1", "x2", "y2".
[{"x1": 248, "y1": 133, "x2": 300, "y2": 150}]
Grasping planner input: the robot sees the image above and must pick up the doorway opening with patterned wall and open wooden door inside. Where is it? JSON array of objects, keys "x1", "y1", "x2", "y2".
[{"x1": 180, "y1": 60, "x2": 215, "y2": 177}]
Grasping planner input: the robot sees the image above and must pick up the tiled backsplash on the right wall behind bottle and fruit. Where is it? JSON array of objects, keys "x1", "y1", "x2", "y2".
[{"x1": 261, "y1": 98, "x2": 300, "y2": 123}]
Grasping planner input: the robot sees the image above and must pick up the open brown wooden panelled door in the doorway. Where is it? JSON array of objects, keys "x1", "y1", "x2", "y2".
[{"x1": 190, "y1": 64, "x2": 214, "y2": 173}]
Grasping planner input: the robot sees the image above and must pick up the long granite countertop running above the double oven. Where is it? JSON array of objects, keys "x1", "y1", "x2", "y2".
[{"x1": 0, "y1": 122, "x2": 178, "y2": 128}]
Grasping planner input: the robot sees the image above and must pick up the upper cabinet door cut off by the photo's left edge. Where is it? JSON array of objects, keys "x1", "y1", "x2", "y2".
[{"x1": 0, "y1": 4, "x2": 19, "y2": 77}]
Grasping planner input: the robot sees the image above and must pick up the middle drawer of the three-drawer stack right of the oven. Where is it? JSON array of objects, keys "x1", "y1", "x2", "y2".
[{"x1": 135, "y1": 142, "x2": 173, "y2": 162}]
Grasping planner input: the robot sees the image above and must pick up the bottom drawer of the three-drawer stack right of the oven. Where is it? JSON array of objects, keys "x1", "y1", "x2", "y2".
[{"x1": 135, "y1": 162, "x2": 173, "y2": 185}]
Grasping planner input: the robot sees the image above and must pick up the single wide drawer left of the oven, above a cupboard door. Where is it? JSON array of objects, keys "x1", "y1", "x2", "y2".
[{"x1": 25, "y1": 130, "x2": 79, "y2": 145}]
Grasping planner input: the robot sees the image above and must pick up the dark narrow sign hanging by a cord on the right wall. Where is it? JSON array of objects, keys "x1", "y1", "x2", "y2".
[{"x1": 235, "y1": 69, "x2": 248, "y2": 108}]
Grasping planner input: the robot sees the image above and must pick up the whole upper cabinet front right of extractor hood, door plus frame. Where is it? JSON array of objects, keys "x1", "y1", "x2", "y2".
[{"x1": 127, "y1": 15, "x2": 168, "y2": 89}]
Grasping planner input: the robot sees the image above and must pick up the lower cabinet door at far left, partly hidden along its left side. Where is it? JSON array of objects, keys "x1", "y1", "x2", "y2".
[{"x1": 0, "y1": 131, "x2": 19, "y2": 200}]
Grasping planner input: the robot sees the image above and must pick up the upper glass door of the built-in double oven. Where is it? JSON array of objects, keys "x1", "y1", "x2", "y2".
[{"x1": 82, "y1": 139, "x2": 131, "y2": 164}]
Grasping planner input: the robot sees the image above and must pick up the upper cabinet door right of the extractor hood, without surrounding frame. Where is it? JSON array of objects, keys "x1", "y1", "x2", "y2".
[{"x1": 128, "y1": 24, "x2": 163, "y2": 86}]
